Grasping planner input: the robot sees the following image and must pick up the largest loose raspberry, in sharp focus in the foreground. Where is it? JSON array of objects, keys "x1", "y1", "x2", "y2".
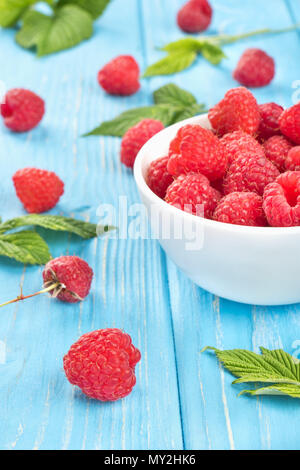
[{"x1": 64, "y1": 328, "x2": 141, "y2": 401}]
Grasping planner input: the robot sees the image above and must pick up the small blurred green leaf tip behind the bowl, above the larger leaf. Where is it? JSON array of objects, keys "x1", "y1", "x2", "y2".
[{"x1": 153, "y1": 83, "x2": 197, "y2": 107}]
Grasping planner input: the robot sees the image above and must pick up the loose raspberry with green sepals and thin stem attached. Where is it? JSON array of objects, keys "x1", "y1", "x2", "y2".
[{"x1": 43, "y1": 256, "x2": 93, "y2": 303}]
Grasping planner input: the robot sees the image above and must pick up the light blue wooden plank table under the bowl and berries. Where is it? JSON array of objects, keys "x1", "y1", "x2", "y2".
[{"x1": 0, "y1": 0, "x2": 300, "y2": 449}]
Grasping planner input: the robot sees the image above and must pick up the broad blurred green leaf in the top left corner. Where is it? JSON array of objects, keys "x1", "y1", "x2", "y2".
[{"x1": 16, "y1": 5, "x2": 93, "y2": 56}]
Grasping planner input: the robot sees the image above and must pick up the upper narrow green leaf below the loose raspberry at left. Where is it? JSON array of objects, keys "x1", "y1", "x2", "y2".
[{"x1": 0, "y1": 214, "x2": 114, "y2": 239}]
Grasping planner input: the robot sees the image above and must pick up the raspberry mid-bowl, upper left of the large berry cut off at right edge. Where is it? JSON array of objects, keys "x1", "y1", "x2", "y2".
[{"x1": 224, "y1": 153, "x2": 279, "y2": 196}]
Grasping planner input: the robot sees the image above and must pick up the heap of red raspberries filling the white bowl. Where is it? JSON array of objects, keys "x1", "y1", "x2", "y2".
[{"x1": 147, "y1": 87, "x2": 300, "y2": 227}]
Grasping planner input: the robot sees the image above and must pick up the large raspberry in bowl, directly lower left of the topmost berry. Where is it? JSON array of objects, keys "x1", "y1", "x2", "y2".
[{"x1": 167, "y1": 124, "x2": 227, "y2": 181}]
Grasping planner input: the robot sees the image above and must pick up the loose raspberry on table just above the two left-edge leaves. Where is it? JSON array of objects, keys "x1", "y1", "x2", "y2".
[{"x1": 12, "y1": 168, "x2": 64, "y2": 213}]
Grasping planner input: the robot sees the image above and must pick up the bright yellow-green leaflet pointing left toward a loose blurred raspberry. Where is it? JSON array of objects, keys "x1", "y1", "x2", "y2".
[{"x1": 143, "y1": 49, "x2": 197, "y2": 77}]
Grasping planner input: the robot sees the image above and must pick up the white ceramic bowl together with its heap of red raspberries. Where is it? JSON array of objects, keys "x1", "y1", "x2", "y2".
[{"x1": 134, "y1": 87, "x2": 300, "y2": 305}]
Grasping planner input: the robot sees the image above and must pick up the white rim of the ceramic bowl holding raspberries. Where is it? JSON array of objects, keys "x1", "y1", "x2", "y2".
[{"x1": 133, "y1": 113, "x2": 300, "y2": 236}]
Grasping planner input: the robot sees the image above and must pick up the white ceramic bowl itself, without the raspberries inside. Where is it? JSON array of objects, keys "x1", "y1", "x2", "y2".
[{"x1": 134, "y1": 115, "x2": 300, "y2": 305}]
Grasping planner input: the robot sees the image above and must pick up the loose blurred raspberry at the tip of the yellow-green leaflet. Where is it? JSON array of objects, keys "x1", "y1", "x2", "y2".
[{"x1": 98, "y1": 55, "x2": 141, "y2": 96}]
